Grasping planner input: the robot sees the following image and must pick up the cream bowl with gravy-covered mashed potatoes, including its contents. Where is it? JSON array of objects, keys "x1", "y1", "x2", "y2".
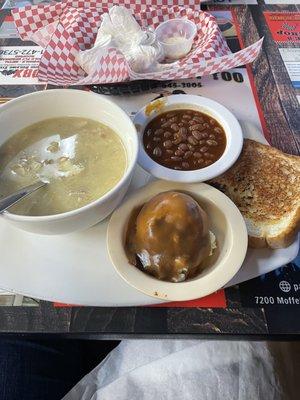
[{"x1": 107, "y1": 181, "x2": 248, "y2": 301}]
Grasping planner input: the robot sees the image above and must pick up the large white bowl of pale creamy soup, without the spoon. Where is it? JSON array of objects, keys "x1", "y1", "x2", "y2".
[{"x1": 0, "y1": 89, "x2": 138, "y2": 234}]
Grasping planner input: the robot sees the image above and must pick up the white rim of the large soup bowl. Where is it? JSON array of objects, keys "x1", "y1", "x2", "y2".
[{"x1": 0, "y1": 89, "x2": 138, "y2": 222}]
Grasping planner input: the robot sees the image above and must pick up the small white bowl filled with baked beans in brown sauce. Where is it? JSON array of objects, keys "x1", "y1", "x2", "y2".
[{"x1": 134, "y1": 94, "x2": 243, "y2": 183}]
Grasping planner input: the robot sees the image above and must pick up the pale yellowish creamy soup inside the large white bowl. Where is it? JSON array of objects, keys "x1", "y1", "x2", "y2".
[{"x1": 0, "y1": 117, "x2": 127, "y2": 216}]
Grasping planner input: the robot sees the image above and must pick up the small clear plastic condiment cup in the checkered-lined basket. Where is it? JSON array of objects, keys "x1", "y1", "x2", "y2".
[{"x1": 155, "y1": 18, "x2": 197, "y2": 60}]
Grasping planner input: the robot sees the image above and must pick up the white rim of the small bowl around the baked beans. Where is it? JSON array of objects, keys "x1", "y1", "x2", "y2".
[{"x1": 133, "y1": 94, "x2": 243, "y2": 182}]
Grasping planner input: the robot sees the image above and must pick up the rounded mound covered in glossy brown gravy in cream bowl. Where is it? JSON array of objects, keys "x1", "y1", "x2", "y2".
[{"x1": 125, "y1": 192, "x2": 211, "y2": 282}]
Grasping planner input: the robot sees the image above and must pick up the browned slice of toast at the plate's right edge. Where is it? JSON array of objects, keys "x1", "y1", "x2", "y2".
[{"x1": 210, "y1": 139, "x2": 300, "y2": 249}]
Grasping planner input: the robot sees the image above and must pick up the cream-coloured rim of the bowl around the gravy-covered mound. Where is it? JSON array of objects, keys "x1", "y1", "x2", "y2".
[{"x1": 107, "y1": 181, "x2": 248, "y2": 301}]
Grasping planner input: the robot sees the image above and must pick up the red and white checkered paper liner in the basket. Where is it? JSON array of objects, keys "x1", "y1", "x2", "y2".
[{"x1": 12, "y1": 0, "x2": 262, "y2": 85}]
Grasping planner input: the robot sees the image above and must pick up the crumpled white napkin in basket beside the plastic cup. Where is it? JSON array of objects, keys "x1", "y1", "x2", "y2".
[{"x1": 76, "y1": 6, "x2": 163, "y2": 74}]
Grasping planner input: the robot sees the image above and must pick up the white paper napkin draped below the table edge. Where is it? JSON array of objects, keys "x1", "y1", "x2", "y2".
[{"x1": 62, "y1": 340, "x2": 284, "y2": 400}]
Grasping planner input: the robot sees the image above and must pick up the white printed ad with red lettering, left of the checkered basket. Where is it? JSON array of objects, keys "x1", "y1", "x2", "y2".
[{"x1": 0, "y1": 46, "x2": 43, "y2": 85}]
